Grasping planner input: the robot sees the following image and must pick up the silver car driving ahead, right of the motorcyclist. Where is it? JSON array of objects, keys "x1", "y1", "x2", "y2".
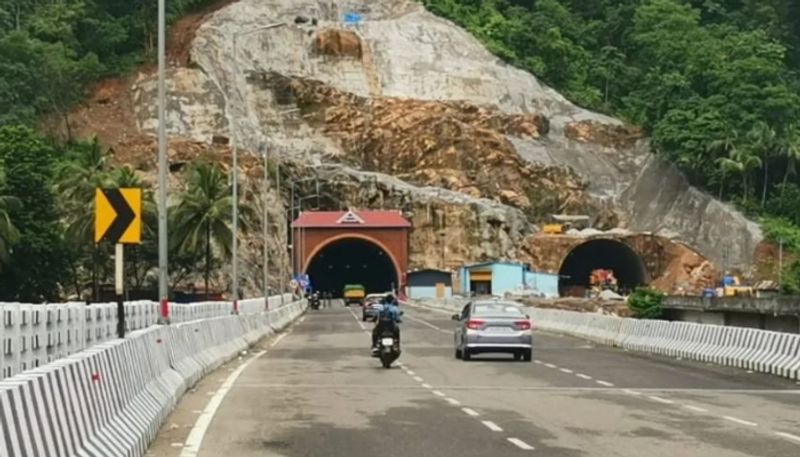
[{"x1": 453, "y1": 300, "x2": 533, "y2": 362}]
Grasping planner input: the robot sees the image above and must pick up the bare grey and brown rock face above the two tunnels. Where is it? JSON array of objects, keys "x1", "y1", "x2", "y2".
[{"x1": 130, "y1": 0, "x2": 762, "y2": 269}]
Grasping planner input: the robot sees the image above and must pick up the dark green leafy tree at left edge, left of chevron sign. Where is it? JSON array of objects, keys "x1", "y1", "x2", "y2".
[{"x1": 0, "y1": 126, "x2": 67, "y2": 302}]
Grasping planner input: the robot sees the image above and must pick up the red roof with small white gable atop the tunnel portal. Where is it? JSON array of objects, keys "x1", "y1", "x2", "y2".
[{"x1": 292, "y1": 210, "x2": 411, "y2": 228}]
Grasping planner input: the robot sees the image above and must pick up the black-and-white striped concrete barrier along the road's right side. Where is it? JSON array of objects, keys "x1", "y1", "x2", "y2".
[{"x1": 529, "y1": 308, "x2": 800, "y2": 380}]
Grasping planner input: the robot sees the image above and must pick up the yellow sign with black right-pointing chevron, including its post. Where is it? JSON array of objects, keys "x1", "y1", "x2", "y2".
[{"x1": 94, "y1": 188, "x2": 142, "y2": 338}]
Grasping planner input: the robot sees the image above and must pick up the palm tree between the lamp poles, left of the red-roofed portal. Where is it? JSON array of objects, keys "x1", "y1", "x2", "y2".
[{"x1": 170, "y1": 162, "x2": 253, "y2": 297}]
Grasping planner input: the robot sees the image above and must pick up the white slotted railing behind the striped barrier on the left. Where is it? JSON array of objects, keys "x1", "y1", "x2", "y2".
[{"x1": 0, "y1": 294, "x2": 292, "y2": 380}]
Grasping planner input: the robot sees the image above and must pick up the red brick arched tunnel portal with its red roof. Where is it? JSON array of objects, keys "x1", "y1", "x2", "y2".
[{"x1": 292, "y1": 210, "x2": 411, "y2": 290}]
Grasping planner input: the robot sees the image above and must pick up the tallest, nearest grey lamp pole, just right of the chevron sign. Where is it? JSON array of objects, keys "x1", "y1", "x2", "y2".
[{"x1": 158, "y1": 0, "x2": 169, "y2": 324}]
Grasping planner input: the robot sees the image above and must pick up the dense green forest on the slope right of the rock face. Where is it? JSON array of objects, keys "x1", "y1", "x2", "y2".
[{"x1": 423, "y1": 0, "x2": 800, "y2": 282}]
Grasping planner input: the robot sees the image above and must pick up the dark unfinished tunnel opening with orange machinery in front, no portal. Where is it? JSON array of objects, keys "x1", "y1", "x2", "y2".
[{"x1": 558, "y1": 240, "x2": 648, "y2": 297}]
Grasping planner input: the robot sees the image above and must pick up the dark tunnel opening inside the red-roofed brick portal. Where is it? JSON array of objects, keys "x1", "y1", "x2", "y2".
[{"x1": 306, "y1": 238, "x2": 398, "y2": 297}]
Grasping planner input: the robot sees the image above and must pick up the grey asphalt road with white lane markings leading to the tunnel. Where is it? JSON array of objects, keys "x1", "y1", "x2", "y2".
[{"x1": 150, "y1": 306, "x2": 800, "y2": 457}]
